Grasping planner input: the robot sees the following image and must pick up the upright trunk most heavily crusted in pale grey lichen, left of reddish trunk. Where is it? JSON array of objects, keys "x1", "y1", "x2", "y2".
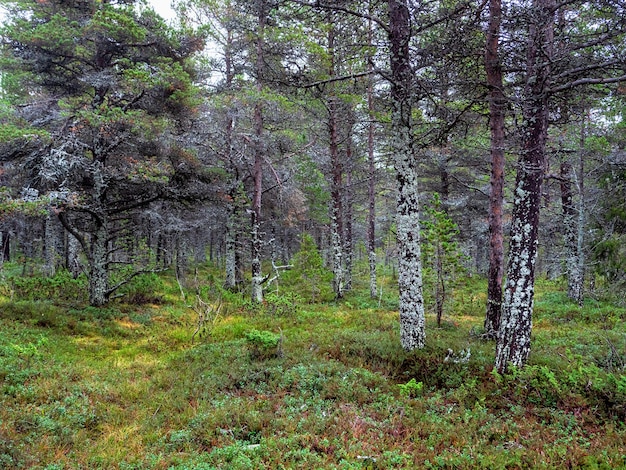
[{"x1": 388, "y1": 0, "x2": 426, "y2": 351}]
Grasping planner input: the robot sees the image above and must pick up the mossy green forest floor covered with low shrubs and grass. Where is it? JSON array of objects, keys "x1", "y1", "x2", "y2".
[{"x1": 0, "y1": 269, "x2": 626, "y2": 469}]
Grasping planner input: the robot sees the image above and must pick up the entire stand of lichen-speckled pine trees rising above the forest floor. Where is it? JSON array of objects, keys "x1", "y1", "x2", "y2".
[{"x1": 2, "y1": 0, "x2": 625, "y2": 370}]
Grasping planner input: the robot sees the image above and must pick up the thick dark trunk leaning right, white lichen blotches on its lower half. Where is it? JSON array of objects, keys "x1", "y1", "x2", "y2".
[{"x1": 495, "y1": 0, "x2": 554, "y2": 373}]
